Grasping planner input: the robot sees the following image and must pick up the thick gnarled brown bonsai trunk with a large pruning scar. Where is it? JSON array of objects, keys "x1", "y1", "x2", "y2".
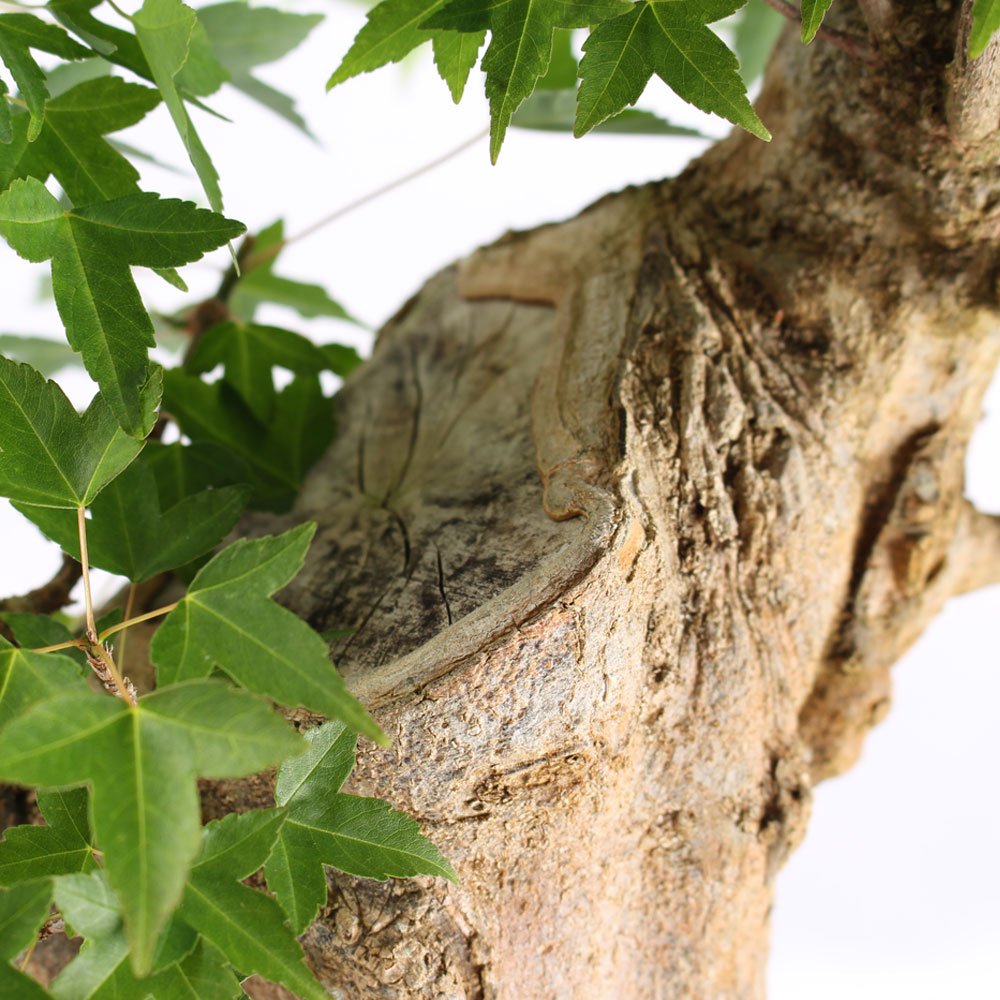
[{"x1": 148, "y1": 0, "x2": 1000, "y2": 1000}]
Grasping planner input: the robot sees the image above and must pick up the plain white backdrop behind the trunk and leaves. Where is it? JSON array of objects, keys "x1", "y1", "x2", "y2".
[{"x1": 0, "y1": 0, "x2": 1000, "y2": 1000}]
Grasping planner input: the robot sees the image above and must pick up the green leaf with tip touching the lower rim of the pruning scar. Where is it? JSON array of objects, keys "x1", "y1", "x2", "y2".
[{"x1": 150, "y1": 523, "x2": 385, "y2": 743}]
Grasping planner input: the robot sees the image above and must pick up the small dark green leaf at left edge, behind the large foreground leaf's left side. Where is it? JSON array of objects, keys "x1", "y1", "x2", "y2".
[{"x1": 0, "y1": 788, "x2": 95, "y2": 885}]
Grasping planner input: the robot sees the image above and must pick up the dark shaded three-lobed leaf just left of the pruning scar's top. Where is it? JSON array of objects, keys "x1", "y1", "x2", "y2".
[{"x1": 184, "y1": 322, "x2": 340, "y2": 424}]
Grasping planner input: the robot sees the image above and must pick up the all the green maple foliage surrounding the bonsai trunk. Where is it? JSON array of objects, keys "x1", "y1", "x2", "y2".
[{"x1": 0, "y1": 0, "x2": 1000, "y2": 1000}]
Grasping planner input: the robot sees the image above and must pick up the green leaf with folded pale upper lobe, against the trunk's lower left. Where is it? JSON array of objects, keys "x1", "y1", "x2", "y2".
[{"x1": 264, "y1": 723, "x2": 456, "y2": 933}]
